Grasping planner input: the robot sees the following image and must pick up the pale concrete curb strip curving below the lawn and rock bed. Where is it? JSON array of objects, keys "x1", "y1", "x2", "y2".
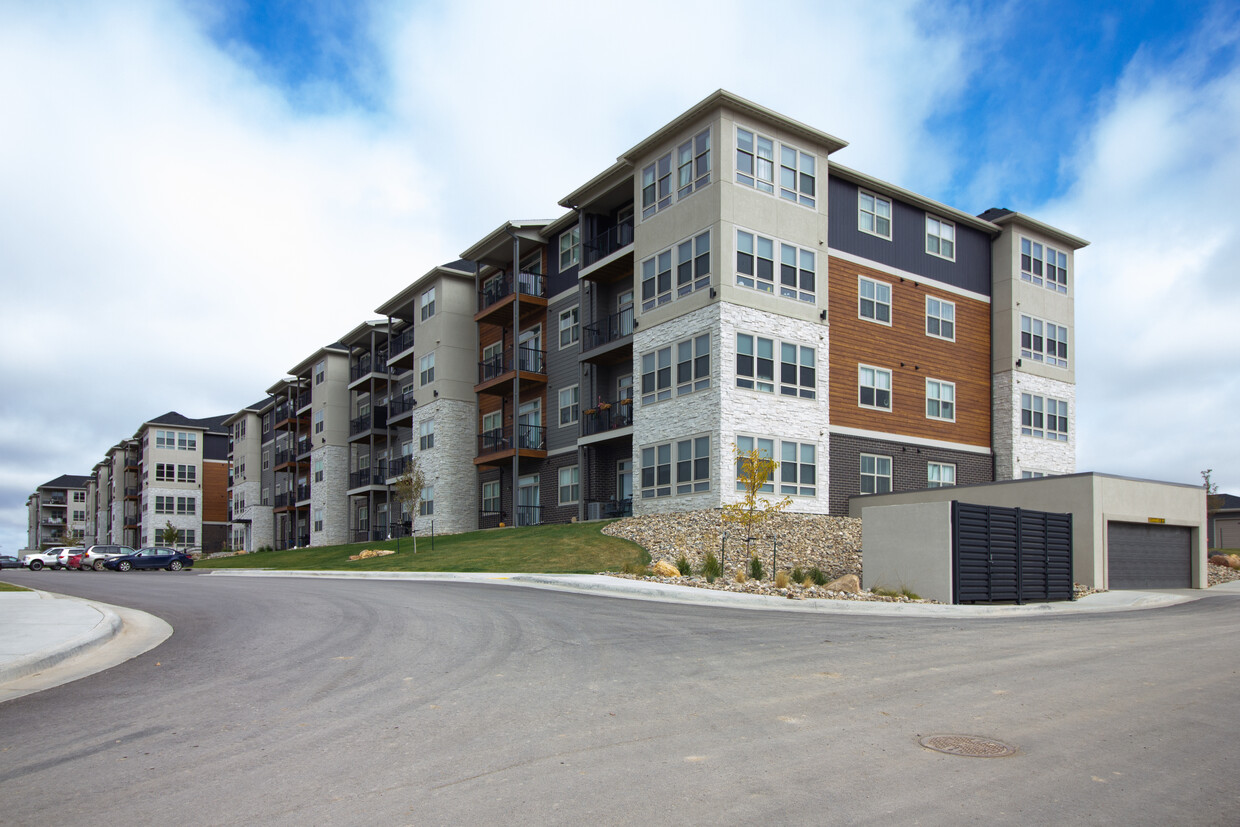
[{"x1": 200, "y1": 569, "x2": 1204, "y2": 619}]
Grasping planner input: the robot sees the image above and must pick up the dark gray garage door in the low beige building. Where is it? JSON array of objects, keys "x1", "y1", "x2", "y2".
[{"x1": 1106, "y1": 522, "x2": 1193, "y2": 589}]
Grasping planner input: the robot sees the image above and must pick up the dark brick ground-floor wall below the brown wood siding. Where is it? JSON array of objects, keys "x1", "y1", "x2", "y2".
[{"x1": 830, "y1": 434, "x2": 994, "y2": 516}]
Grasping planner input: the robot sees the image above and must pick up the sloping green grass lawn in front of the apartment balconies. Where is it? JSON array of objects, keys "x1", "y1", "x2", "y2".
[{"x1": 193, "y1": 521, "x2": 650, "y2": 574}]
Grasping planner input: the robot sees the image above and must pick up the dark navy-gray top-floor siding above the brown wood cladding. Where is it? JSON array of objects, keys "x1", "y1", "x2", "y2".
[{"x1": 827, "y1": 176, "x2": 991, "y2": 295}]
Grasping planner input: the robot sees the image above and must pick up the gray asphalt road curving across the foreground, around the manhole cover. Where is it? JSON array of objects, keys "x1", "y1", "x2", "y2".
[{"x1": 0, "y1": 572, "x2": 1240, "y2": 825}]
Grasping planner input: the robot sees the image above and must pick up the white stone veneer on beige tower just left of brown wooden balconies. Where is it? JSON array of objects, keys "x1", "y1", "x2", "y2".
[{"x1": 413, "y1": 399, "x2": 481, "y2": 534}]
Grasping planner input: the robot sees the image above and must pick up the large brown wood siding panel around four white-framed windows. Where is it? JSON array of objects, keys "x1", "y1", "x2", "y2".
[{"x1": 828, "y1": 258, "x2": 991, "y2": 446}]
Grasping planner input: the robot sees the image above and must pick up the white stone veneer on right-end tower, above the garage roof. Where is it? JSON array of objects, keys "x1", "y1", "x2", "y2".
[{"x1": 991, "y1": 371, "x2": 1076, "y2": 480}]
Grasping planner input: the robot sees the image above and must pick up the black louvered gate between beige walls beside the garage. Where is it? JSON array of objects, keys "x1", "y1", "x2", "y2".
[{"x1": 951, "y1": 502, "x2": 1073, "y2": 603}]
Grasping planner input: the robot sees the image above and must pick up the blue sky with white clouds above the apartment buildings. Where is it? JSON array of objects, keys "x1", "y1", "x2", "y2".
[{"x1": 0, "y1": 0, "x2": 1240, "y2": 553}]
